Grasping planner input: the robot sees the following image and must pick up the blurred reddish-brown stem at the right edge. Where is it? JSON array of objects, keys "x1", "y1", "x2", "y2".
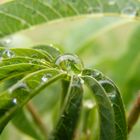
[{"x1": 128, "y1": 91, "x2": 140, "y2": 133}]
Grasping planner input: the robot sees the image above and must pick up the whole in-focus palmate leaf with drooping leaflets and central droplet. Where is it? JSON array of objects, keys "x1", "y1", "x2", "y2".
[{"x1": 0, "y1": 46, "x2": 127, "y2": 140}]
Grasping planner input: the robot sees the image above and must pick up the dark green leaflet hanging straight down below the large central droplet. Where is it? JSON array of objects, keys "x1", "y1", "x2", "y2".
[{"x1": 50, "y1": 76, "x2": 83, "y2": 140}]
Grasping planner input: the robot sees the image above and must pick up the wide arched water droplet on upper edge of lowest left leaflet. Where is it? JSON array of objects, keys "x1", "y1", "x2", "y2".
[{"x1": 9, "y1": 82, "x2": 29, "y2": 94}]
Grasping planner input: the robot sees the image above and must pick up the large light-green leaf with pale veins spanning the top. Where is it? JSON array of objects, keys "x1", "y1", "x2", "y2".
[{"x1": 0, "y1": 0, "x2": 140, "y2": 37}]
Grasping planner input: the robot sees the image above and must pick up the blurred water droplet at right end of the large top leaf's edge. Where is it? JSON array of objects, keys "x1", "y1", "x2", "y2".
[{"x1": 121, "y1": 5, "x2": 137, "y2": 17}]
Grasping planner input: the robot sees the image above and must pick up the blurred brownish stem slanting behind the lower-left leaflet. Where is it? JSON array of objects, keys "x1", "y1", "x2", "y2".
[{"x1": 27, "y1": 101, "x2": 48, "y2": 140}]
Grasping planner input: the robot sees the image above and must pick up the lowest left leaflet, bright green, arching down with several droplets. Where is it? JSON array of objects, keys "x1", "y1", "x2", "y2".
[{"x1": 0, "y1": 69, "x2": 65, "y2": 132}]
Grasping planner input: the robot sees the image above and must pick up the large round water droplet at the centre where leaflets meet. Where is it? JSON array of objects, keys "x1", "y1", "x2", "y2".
[{"x1": 55, "y1": 54, "x2": 83, "y2": 74}]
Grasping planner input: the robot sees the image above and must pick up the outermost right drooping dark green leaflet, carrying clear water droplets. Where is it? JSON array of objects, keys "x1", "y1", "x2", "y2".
[{"x1": 83, "y1": 69, "x2": 127, "y2": 140}]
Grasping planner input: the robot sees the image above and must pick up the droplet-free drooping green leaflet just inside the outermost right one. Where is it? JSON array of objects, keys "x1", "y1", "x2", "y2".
[{"x1": 82, "y1": 72, "x2": 115, "y2": 140}]
